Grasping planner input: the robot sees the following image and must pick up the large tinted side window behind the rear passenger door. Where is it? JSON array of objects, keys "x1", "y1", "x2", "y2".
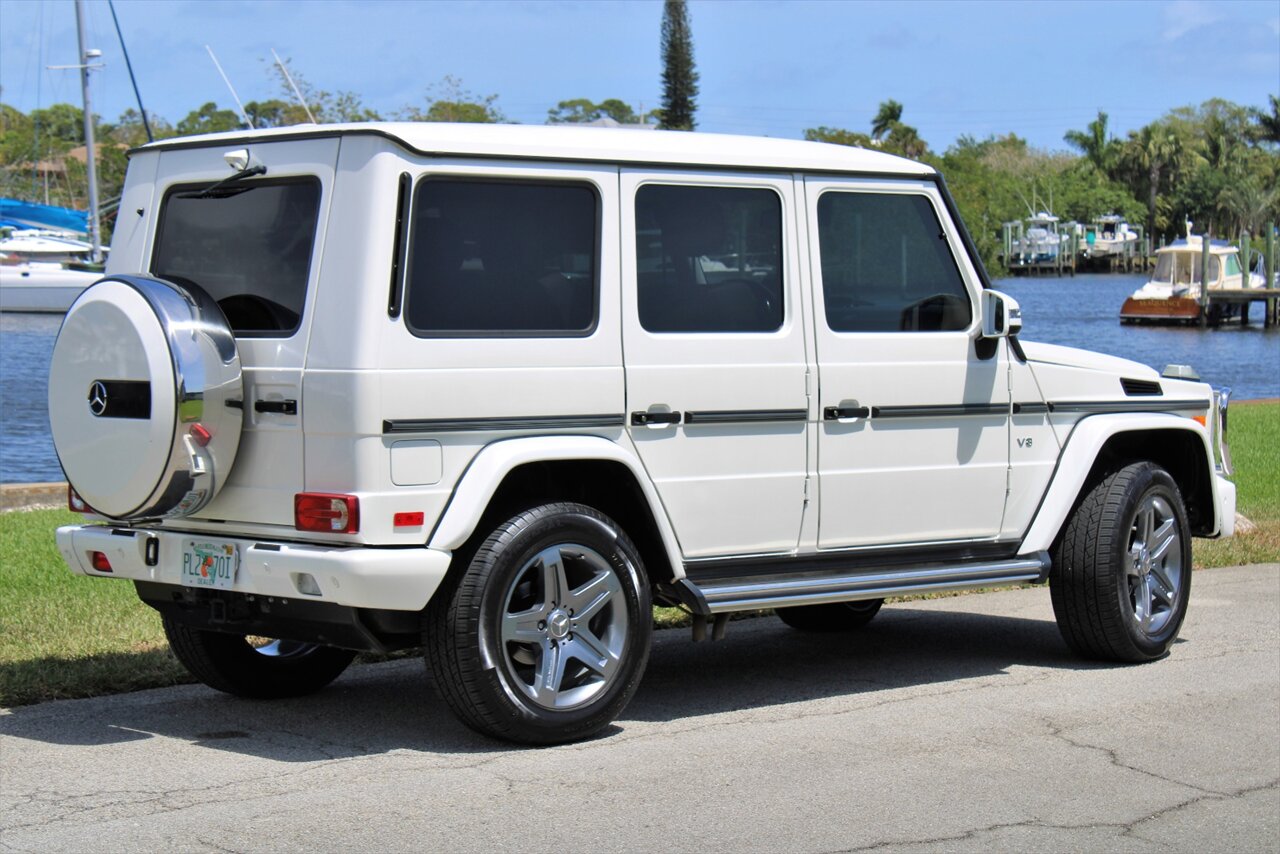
[{"x1": 404, "y1": 181, "x2": 598, "y2": 337}]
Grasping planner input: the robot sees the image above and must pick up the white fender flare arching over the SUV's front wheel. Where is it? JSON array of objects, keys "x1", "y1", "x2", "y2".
[{"x1": 1019, "y1": 412, "x2": 1218, "y2": 554}]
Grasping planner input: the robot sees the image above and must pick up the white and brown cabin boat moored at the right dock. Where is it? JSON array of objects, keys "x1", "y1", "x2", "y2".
[{"x1": 1120, "y1": 229, "x2": 1266, "y2": 324}]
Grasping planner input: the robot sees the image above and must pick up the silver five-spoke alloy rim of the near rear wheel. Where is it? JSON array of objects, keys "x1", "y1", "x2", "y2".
[{"x1": 499, "y1": 543, "x2": 628, "y2": 711}]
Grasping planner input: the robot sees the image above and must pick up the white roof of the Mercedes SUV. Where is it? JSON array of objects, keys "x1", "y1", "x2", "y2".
[{"x1": 141, "y1": 122, "x2": 934, "y2": 177}]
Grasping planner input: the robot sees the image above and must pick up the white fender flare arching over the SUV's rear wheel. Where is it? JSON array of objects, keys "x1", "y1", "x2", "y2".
[{"x1": 428, "y1": 435, "x2": 685, "y2": 581}]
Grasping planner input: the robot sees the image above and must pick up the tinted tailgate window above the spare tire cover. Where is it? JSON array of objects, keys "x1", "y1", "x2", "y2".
[{"x1": 151, "y1": 178, "x2": 320, "y2": 338}]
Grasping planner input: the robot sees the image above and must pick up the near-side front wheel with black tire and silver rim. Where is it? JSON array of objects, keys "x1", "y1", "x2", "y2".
[{"x1": 1050, "y1": 462, "x2": 1192, "y2": 662}]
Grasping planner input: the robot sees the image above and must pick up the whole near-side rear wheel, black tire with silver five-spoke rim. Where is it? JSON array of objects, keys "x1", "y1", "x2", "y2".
[{"x1": 422, "y1": 503, "x2": 653, "y2": 744}]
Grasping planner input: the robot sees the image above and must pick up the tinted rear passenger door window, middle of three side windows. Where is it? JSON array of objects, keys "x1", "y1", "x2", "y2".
[{"x1": 636, "y1": 186, "x2": 782, "y2": 332}]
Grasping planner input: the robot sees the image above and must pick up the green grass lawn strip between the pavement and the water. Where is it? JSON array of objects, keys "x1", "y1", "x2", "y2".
[{"x1": 0, "y1": 399, "x2": 1280, "y2": 708}]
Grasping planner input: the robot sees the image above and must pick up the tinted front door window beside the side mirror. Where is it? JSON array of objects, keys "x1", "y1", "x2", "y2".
[{"x1": 818, "y1": 192, "x2": 970, "y2": 332}]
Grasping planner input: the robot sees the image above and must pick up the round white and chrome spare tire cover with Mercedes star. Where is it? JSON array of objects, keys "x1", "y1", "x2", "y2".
[{"x1": 49, "y1": 275, "x2": 243, "y2": 520}]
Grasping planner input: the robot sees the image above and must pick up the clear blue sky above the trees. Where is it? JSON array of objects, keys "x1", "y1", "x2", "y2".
[{"x1": 0, "y1": 0, "x2": 1280, "y2": 150}]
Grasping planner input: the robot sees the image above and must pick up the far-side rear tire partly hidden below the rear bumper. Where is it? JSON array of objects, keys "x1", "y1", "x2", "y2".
[{"x1": 163, "y1": 617, "x2": 356, "y2": 699}]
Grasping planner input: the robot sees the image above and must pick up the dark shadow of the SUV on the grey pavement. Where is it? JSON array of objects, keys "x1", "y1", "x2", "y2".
[{"x1": 0, "y1": 606, "x2": 1131, "y2": 762}]
